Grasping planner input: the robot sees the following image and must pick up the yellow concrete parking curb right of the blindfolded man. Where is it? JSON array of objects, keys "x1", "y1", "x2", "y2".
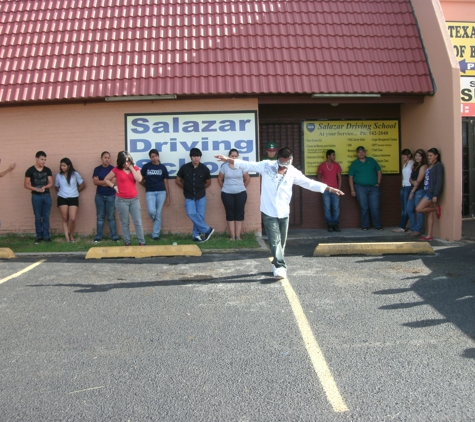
[{"x1": 313, "y1": 242, "x2": 434, "y2": 256}]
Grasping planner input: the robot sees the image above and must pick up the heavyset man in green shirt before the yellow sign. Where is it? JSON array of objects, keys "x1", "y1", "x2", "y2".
[{"x1": 348, "y1": 146, "x2": 383, "y2": 230}]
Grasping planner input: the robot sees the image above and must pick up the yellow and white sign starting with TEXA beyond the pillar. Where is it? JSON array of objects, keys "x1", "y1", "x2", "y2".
[{"x1": 446, "y1": 22, "x2": 475, "y2": 116}]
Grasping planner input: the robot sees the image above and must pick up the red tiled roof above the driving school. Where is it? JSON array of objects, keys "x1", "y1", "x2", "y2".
[{"x1": 0, "y1": 0, "x2": 434, "y2": 103}]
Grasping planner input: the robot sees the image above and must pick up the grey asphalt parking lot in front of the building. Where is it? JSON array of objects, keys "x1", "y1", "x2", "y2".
[{"x1": 0, "y1": 232, "x2": 475, "y2": 421}]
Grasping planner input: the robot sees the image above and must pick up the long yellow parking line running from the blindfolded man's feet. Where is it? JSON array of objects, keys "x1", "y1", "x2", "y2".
[{"x1": 281, "y1": 278, "x2": 348, "y2": 412}]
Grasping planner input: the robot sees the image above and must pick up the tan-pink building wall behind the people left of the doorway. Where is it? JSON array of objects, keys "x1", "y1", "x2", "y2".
[{"x1": 0, "y1": 99, "x2": 261, "y2": 234}]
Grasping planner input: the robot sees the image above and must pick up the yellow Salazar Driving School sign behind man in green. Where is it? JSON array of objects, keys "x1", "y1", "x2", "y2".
[{"x1": 302, "y1": 120, "x2": 401, "y2": 176}]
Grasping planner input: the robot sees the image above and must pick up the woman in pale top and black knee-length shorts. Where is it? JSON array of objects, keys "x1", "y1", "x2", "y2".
[{"x1": 218, "y1": 148, "x2": 251, "y2": 241}]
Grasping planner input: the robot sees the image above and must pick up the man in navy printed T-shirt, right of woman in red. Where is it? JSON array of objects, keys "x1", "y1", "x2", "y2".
[{"x1": 140, "y1": 149, "x2": 170, "y2": 240}]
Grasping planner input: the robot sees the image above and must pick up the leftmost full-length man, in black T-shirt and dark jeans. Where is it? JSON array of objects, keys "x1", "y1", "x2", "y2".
[{"x1": 23, "y1": 151, "x2": 53, "y2": 245}]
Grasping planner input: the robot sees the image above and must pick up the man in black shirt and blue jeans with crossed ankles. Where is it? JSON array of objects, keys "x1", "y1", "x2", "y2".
[{"x1": 175, "y1": 148, "x2": 214, "y2": 242}]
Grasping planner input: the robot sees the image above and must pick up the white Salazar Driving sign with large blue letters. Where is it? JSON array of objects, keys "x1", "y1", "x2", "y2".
[{"x1": 125, "y1": 111, "x2": 257, "y2": 177}]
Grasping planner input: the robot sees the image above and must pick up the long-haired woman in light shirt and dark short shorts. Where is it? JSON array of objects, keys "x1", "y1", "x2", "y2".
[{"x1": 54, "y1": 158, "x2": 86, "y2": 242}]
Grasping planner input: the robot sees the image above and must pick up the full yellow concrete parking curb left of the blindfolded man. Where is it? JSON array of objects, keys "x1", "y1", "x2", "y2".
[{"x1": 86, "y1": 245, "x2": 202, "y2": 259}]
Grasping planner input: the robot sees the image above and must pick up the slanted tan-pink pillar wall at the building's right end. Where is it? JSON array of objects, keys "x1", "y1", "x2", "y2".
[{"x1": 401, "y1": 0, "x2": 462, "y2": 240}]
